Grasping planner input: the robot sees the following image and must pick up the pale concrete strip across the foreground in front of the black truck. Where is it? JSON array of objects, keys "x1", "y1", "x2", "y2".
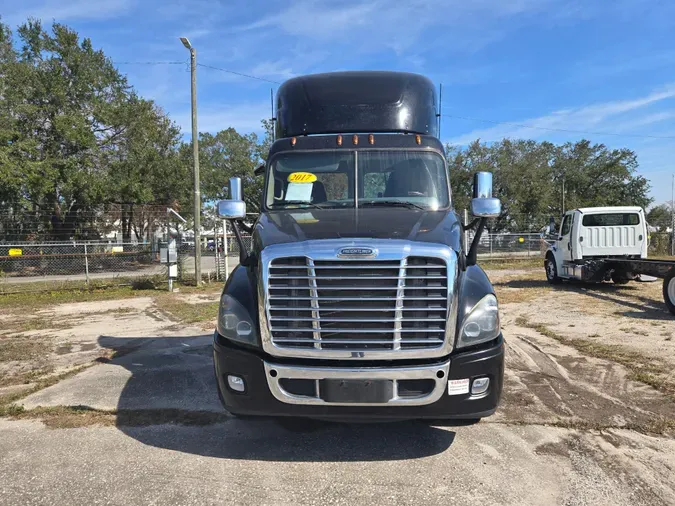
[{"x1": 0, "y1": 420, "x2": 675, "y2": 506}]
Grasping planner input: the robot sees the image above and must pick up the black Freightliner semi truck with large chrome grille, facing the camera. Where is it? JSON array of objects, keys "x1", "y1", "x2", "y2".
[{"x1": 213, "y1": 72, "x2": 504, "y2": 420}]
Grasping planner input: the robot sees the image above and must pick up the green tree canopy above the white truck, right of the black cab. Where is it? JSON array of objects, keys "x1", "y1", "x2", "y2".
[{"x1": 447, "y1": 139, "x2": 651, "y2": 231}]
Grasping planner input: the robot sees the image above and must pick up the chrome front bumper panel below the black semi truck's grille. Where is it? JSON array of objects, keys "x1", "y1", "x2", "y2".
[{"x1": 264, "y1": 361, "x2": 450, "y2": 406}]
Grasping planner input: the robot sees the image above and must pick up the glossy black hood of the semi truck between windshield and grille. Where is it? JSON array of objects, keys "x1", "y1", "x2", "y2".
[{"x1": 253, "y1": 207, "x2": 461, "y2": 250}]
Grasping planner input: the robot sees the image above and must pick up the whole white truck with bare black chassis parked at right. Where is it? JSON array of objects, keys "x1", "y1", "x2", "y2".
[{"x1": 544, "y1": 206, "x2": 675, "y2": 314}]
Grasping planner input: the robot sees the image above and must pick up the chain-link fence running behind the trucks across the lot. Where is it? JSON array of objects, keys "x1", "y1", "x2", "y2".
[{"x1": 0, "y1": 226, "x2": 671, "y2": 293}]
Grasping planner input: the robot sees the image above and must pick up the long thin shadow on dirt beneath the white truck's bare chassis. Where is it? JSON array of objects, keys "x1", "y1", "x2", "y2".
[{"x1": 494, "y1": 279, "x2": 675, "y2": 321}]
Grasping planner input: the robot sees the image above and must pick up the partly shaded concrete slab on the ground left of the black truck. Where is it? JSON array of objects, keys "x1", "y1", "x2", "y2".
[{"x1": 21, "y1": 335, "x2": 222, "y2": 411}]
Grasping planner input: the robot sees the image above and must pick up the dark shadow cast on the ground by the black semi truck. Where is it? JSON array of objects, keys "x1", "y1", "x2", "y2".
[{"x1": 99, "y1": 335, "x2": 455, "y2": 462}]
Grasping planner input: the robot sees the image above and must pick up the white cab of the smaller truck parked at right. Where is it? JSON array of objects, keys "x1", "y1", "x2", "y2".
[{"x1": 545, "y1": 207, "x2": 648, "y2": 283}]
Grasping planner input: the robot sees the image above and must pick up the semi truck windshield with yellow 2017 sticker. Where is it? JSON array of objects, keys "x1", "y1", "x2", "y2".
[{"x1": 266, "y1": 150, "x2": 450, "y2": 211}]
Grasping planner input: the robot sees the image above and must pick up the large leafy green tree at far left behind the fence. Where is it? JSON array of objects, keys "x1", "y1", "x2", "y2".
[{"x1": 0, "y1": 20, "x2": 186, "y2": 239}]
